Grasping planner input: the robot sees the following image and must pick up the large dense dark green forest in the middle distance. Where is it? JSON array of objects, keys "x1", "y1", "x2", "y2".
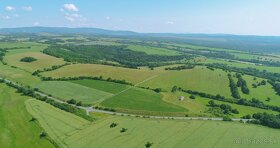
[{"x1": 44, "y1": 45, "x2": 193, "y2": 68}]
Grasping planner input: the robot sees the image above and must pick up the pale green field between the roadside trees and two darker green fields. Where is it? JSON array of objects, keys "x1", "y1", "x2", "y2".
[{"x1": 35, "y1": 81, "x2": 112, "y2": 104}]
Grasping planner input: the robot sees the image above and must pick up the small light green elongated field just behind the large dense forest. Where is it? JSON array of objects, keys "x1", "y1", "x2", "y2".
[{"x1": 128, "y1": 45, "x2": 180, "y2": 56}]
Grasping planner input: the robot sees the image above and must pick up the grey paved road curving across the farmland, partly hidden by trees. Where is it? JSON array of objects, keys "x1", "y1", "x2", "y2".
[{"x1": 0, "y1": 77, "x2": 252, "y2": 122}]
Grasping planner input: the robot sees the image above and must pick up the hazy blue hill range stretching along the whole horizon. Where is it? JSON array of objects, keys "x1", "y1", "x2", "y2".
[{"x1": 0, "y1": 27, "x2": 280, "y2": 53}]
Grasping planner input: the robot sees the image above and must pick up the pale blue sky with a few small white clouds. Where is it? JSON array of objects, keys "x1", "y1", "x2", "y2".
[{"x1": 0, "y1": 0, "x2": 280, "y2": 36}]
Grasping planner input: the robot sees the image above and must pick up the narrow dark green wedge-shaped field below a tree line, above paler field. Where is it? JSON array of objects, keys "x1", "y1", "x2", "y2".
[{"x1": 69, "y1": 80, "x2": 129, "y2": 94}]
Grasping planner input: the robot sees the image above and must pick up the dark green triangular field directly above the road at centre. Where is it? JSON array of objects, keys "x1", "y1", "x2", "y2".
[{"x1": 101, "y1": 87, "x2": 186, "y2": 113}]
